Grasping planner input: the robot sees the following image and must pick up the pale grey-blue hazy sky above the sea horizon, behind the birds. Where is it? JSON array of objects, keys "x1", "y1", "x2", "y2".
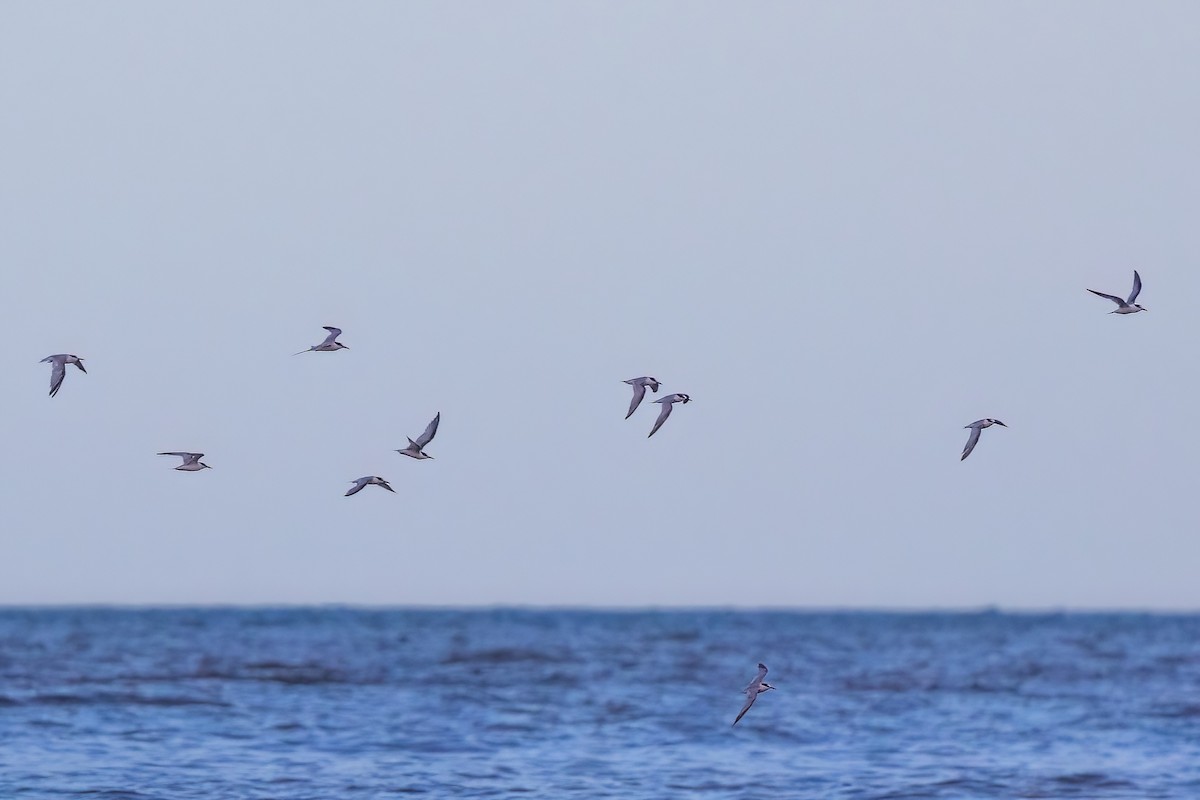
[{"x1": 0, "y1": 1, "x2": 1200, "y2": 608}]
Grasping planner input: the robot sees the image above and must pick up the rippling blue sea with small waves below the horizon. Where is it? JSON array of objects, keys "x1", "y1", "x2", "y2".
[{"x1": 0, "y1": 608, "x2": 1200, "y2": 800}]
